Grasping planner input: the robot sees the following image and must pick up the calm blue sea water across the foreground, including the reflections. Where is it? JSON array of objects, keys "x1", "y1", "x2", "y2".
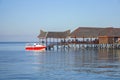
[{"x1": 0, "y1": 42, "x2": 120, "y2": 80}]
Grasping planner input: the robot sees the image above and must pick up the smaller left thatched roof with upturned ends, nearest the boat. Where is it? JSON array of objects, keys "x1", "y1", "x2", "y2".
[{"x1": 38, "y1": 30, "x2": 70, "y2": 38}]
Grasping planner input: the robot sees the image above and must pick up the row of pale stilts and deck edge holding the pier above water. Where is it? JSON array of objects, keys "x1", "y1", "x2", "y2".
[{"x1": 44, "y1": 43, "x2": 120, "y2": 50}]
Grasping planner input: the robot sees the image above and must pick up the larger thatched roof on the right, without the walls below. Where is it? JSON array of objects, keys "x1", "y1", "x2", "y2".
[{"x1": 70, "y1": 27, "x2": 120, "y2": 38}]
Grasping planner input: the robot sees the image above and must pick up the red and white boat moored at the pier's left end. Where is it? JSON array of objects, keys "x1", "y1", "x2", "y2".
[{"x1": 25, "y1": 43, "x2": 46, "y2": 50}]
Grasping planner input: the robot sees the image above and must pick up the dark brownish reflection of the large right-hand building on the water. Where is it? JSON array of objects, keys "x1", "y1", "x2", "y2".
[{"x1": 69, "y1": 49, "x2": 120, "y2": 78}]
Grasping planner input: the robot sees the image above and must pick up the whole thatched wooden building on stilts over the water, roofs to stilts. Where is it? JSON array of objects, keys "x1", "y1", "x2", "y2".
[{"x1": 38, "y1": 27, "x2": 120, "y2": 50}]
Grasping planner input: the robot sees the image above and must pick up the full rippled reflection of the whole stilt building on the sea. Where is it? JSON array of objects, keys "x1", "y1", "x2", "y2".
[{"x1": 32, "y1": 49, "x2": 120, "y2": 78}]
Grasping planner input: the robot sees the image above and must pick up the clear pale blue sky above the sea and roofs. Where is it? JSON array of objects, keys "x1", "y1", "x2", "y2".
[{"x1": 0, "y1": 0, "x2": 120, "y2": 41}]
